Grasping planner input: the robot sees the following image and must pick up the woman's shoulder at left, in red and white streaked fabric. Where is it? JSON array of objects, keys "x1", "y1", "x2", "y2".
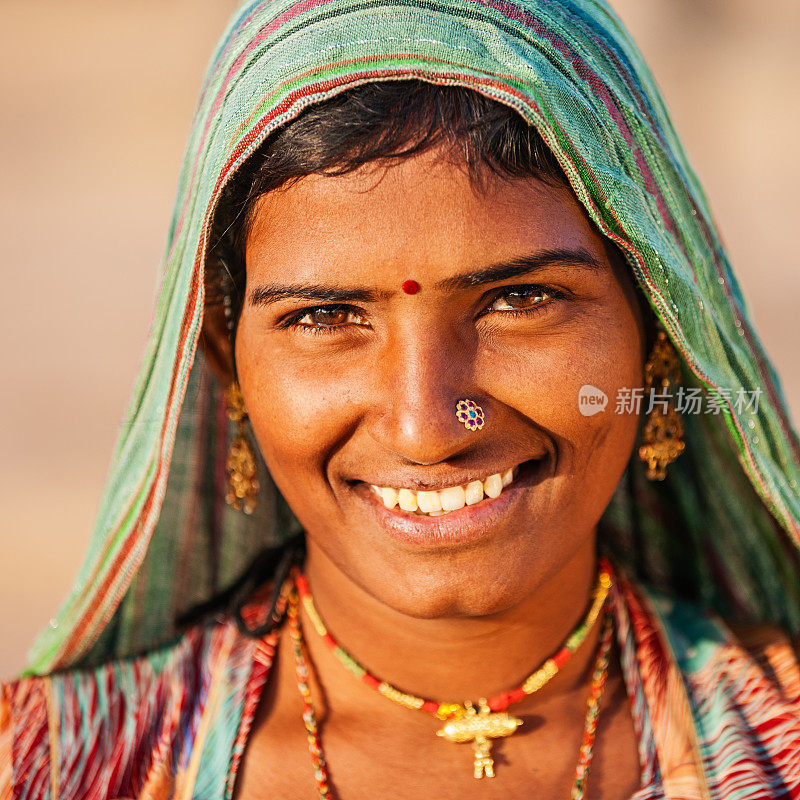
[{"x1": 0, "y1": 618, "x2": 260, "y2": 800}]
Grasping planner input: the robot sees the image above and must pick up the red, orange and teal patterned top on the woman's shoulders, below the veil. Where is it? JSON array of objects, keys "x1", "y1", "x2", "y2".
[{"x1": 0, "y1": 564, "x2": 800, "y2": 800}]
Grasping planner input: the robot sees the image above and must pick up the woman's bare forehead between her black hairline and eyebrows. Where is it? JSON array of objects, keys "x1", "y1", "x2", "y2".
[{"x1": 246, "y1": 151, "x2": 607, "y2": 283}]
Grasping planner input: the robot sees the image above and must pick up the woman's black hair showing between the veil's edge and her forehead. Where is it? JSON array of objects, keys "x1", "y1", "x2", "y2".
[{"x1": 206, "y1": 79, "x2": 569, "y2": 340}]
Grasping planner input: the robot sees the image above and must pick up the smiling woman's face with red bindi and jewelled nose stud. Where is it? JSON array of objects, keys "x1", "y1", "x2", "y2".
[{"x1": 236, "y1": 145, "x2": 645, "y2": 617}]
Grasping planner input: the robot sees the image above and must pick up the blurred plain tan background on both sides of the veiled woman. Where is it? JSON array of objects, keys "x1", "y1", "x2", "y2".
[{"x1": 0, "y1": 0, "x2": 800, "y2": 677}]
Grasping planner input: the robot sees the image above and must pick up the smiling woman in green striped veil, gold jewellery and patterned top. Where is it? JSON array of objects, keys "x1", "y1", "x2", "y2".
[{"x1": 0, "y1": 0, "x2": 800, "y2": 799}]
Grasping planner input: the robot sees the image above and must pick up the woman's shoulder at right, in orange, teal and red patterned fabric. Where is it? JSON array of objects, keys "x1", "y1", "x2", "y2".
[{"x1": 628, "y1": 584, "x2": 800, "y2": 797}]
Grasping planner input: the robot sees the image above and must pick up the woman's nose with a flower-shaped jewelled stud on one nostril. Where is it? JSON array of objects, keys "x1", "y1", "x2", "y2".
[{"x1": 371, "y1": 328, "x2": 488, "y2": 464}]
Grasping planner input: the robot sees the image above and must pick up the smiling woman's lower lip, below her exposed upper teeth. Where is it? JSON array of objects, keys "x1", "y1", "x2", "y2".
[{"x1": 356, "y1": 456, "x2": 549, "y2": 549}]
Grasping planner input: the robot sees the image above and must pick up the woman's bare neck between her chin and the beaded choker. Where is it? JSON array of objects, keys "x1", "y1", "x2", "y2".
[{"x1": 301, "y1": 537, "x2": 601, "y2": 702}]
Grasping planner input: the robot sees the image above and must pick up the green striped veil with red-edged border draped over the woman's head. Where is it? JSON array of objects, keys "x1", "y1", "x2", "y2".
[{"x1": 28, "y1": 0, "x2": 800, "y2": 673}]
